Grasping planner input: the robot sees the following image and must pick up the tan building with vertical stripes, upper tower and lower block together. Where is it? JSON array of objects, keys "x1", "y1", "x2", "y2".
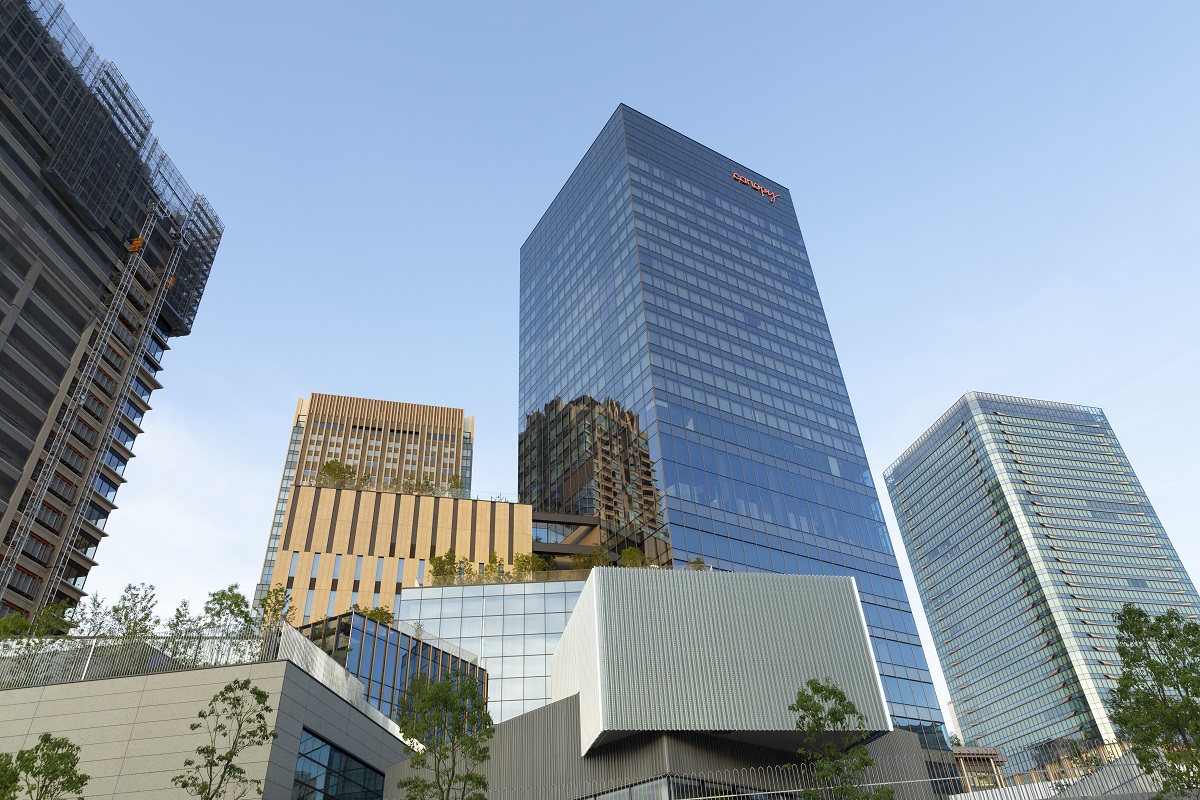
[{"x1": 254, "y1": 392, "x2": 511, "y2": 615}]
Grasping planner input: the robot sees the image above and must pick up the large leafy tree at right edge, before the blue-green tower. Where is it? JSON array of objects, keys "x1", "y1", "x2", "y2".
[{"x1": 1109, "y1": 604, "x2": 1200, "y2": 798}]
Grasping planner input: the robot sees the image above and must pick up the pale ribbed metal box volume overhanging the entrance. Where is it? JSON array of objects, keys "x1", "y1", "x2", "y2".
[{"x1": 551, "y1": 569, "x2": 892, "y2": 752}]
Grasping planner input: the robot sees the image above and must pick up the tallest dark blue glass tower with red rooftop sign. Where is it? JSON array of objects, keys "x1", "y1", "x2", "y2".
[{"x1": 518, "y1": 106, "x2": 942, "y2": 746}]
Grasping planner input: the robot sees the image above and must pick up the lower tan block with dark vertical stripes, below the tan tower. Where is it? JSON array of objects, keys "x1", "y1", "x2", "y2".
[{"x1": 270, "y1": 486, "x2": 533, "y2": 622}]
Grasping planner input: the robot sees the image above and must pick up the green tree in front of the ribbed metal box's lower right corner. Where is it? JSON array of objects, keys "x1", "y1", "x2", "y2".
[{"x1": 787, "y1": 678, "x2": 893, "y2": 800}]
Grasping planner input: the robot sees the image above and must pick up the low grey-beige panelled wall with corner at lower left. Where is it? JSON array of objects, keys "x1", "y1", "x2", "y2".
[{"x1": 0, "y1": 661, "x2": 404, "y2": 800}]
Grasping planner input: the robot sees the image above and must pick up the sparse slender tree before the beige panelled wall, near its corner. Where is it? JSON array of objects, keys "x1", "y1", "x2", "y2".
[{"x1": 170, "y1": 680, "x2": 276, "y2": 800}]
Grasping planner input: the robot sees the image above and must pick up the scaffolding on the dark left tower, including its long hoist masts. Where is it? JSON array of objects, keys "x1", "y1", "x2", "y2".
[{"x1": 0, "y1": 0, "x2": 224, "y2": 613}]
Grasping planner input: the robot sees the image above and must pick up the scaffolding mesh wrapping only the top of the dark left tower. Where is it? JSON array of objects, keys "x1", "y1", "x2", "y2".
[{"x1": 0, "y1": 0, "x2": 224, "y2": 336}]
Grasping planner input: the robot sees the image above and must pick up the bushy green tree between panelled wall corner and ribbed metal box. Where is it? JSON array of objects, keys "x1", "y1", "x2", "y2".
[{"x1": 396, "y1": 670, "x2": 494, "y2": 800}]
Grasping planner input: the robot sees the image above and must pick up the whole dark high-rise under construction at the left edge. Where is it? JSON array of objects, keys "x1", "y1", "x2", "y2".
[{"x1": 0, "y1": 0, "x2": 223, "y2": 615}]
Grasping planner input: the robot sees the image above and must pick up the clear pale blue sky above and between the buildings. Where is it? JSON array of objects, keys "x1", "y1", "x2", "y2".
[{"x1": 68, "y1": 0, "x2": 1200, "y2": 724}]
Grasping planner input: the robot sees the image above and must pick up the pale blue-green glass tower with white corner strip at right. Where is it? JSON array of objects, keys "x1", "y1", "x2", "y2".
[{"x1": 884, "y1": 392, "x2": 1200, "y2": 752}]
